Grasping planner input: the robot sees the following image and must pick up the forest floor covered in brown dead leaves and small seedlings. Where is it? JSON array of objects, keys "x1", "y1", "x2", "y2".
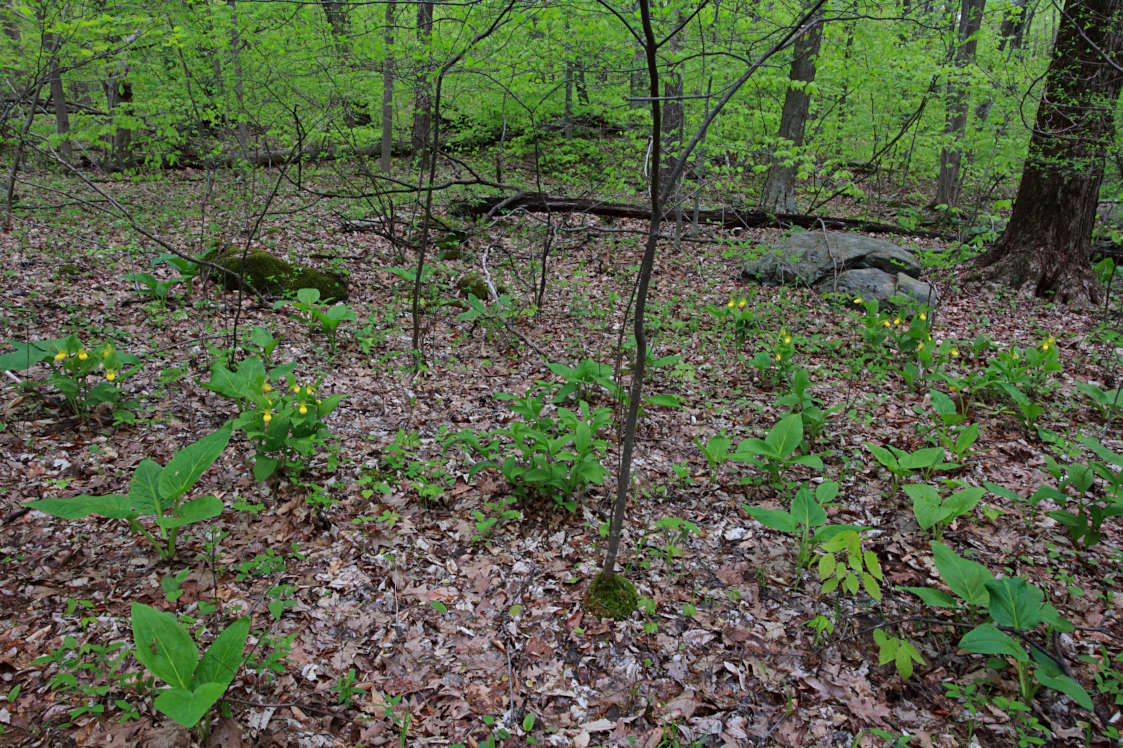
[{"x1": 0, "y1": 168, "x2": 1123, "y2": 748}]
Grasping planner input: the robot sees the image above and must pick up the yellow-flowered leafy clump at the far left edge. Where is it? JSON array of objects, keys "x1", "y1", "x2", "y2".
[{"x1": 0, "y1": 335, "x2": 140, "y2": 421}]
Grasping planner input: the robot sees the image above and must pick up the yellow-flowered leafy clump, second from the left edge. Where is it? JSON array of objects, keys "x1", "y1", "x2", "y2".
[{"x1": 202, "y1": 356, "x2": 345, "y2": 481}]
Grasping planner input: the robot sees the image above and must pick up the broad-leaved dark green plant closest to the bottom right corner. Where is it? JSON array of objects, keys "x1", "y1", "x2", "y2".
[{"x1": 904, "y1": 540, "x2": 1092, "y2": 711}]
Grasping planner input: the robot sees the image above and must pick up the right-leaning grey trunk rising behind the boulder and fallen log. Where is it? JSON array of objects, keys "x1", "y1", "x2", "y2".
[{"x1": 760, "y1": 5, "x2": 823, "y2": 213}]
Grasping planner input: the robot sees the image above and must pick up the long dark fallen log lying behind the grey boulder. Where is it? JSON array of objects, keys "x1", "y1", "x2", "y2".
[{"x1": 449, "y1": 192, "x2": 951, "y2": 239}]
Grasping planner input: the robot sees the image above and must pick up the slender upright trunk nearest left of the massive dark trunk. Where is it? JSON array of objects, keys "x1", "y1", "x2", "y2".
[{"x1": 932, "y1": 0, "x2": 986, "y2": 208}]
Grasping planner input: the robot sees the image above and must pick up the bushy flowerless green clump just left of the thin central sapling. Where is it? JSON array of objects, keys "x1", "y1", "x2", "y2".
[{"x1": 446, "y1": 387, "x2": 612, "y2": 511}]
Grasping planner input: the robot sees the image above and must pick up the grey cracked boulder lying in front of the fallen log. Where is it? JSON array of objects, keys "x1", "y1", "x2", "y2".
[{"x1": 741, "y1": 231, "x2": 932, "y2": 304}]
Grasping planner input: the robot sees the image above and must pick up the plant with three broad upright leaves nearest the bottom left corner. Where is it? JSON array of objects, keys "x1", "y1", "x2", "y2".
[{"x1": 133, "y1": 603, "x2": 249, "y2": 728}]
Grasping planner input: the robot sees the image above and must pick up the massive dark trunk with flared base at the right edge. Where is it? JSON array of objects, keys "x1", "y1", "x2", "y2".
[{"x1": 977, "y1": 0, "x2": 1123, "y2": 303}]
